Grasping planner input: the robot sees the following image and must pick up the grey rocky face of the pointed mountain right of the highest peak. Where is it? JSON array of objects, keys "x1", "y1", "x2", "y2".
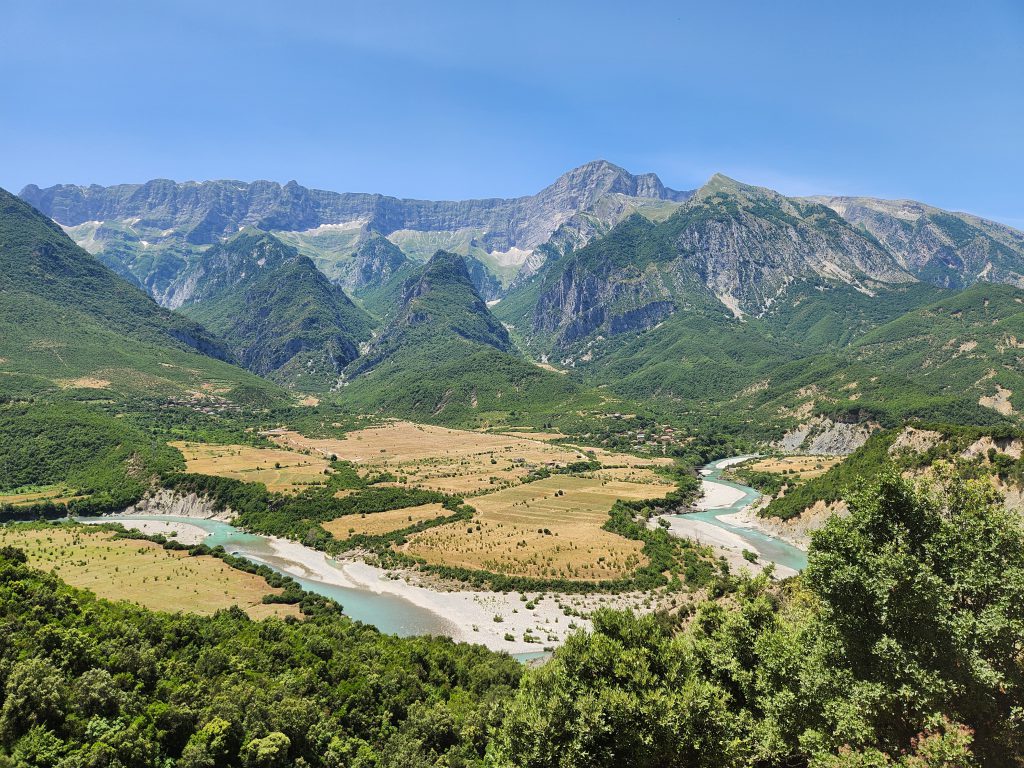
[{"x1": 503, "y1": 175, "x2": 914, "y2": 352}]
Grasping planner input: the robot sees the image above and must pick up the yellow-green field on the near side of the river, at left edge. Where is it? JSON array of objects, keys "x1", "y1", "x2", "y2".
[{"x1": 0, "y1": 526, "x2": 299, "y2": 618}]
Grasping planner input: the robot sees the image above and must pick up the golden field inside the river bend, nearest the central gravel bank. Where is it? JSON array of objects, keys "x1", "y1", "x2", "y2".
[{"x1": 403, "y1": 470, "x2": 674, "y2": 581}]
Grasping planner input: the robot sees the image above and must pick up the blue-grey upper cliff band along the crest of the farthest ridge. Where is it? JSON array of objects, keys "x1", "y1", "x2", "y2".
[{"x1": 22, "y1": 161, "x2": 689, "y2": 250}]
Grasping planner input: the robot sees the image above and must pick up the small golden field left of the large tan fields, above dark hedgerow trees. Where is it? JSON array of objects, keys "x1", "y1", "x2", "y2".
[{"x1": 170, "y1": 441, "x2": 330, "y2": 494}]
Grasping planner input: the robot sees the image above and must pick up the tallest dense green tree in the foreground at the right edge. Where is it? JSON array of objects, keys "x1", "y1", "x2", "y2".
[{"x1": 805, "y1": 472, "x2": 1024, "y2": 766}]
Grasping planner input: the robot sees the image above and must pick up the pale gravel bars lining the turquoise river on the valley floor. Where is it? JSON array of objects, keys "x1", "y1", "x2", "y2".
[{"x1": 92, "y1": 450, "x2": 797, "y2": 654}]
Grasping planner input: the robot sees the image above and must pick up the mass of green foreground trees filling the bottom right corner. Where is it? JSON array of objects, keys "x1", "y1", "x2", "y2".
[{"x1": 492, "y1": 474, "x2": 1024, "y2": 768}]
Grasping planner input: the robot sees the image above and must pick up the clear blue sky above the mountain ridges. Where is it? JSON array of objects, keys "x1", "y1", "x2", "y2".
[{"x1": 0, "y1": 0, "x2": 1024, "y2": 227}]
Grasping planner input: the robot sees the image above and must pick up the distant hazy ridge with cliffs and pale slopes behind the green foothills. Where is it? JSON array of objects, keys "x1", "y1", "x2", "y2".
[{"x1": 22, "y1": 161, "x2": 690, "y2": 302}]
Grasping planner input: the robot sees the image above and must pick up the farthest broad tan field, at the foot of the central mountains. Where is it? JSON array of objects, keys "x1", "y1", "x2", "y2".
[{"x1": 268, "y1": 421, "x2": 671, "y2": 495}]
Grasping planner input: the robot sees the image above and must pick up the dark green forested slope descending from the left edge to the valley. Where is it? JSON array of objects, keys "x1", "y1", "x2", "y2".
[{"x1": 0, "y1": 190, "x2": 282, "y2": 401}]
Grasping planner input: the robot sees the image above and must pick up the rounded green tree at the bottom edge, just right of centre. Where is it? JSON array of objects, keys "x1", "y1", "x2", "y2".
[{"x1": 489, "y1": 610, "x2": 743, "y2": 768}]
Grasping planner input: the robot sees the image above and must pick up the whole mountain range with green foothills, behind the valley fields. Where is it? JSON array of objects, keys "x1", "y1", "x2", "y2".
[{"x1": 12, "y1": 161, "x2": 1024, "y2": 438}]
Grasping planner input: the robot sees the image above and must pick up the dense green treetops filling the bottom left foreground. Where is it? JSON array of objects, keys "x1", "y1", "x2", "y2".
[{"x1": 0, "y1": 550, "x2": 521, "y2": 768}]
